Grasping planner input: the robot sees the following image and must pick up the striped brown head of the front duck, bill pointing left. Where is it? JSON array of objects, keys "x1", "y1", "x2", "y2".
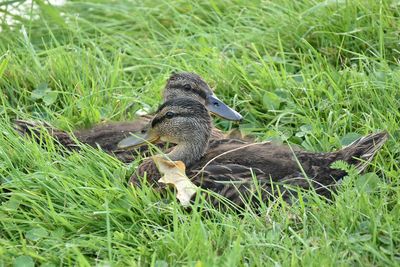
[{"x1": 119, "y1": 97, "x2": 212, "y2": 165}]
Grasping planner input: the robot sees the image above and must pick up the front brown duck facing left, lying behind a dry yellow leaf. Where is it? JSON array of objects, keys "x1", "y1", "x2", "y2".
[{"x1": 126, "y1": 98, "x2": 388, "y2": 207}]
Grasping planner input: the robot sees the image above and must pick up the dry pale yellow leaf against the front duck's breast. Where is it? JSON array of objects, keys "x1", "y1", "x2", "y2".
[{"x1": 153, "y1": 155, "x2": 197, "y2": 207}]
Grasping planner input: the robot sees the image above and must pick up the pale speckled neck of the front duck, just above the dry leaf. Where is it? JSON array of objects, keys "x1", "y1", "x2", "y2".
[{"x1": 167, "y1": 135, "x2": 209, "y2": 166}]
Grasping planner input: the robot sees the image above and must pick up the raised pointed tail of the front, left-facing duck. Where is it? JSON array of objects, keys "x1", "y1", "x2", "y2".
[{"x1": 341, "y1": 131, "x2": 388, "y2": 173}]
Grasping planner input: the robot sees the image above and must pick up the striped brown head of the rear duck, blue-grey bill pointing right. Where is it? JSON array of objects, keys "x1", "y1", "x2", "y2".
[{"x1": 163, "y1": 72, "x2": 242, "y2": 121}]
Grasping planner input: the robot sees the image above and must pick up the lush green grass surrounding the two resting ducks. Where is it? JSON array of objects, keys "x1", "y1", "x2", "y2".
[{"x1": 0, "y1": 0, "x2": 400, "y2": 266}]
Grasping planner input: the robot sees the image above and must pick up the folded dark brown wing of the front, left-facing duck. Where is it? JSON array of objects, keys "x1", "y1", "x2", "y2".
[{"x1": 189, "y1": 136, "x2": 346, "y2": 207}]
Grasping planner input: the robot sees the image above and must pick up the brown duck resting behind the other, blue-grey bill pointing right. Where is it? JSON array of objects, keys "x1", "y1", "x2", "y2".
[{"x1": 14, "y1": 72, "x2": 242, "y2": 163}]
